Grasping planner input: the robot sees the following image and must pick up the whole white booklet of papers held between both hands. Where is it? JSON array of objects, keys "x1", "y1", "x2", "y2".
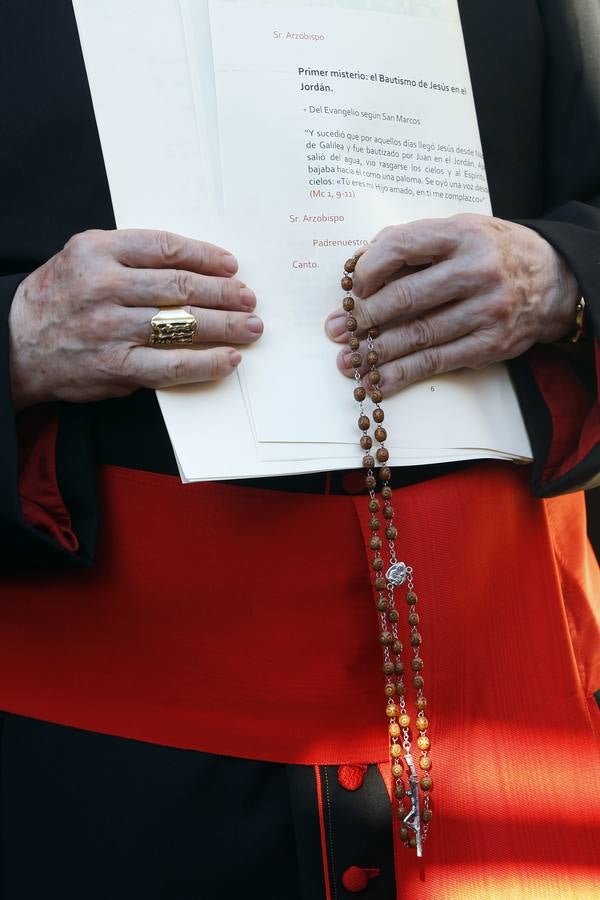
[{"x1": 74, "y1": 0, "x2": 531, "y2": 480}]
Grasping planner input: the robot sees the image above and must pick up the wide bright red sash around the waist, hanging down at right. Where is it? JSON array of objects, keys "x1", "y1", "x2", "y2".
[{"x1": 0, "y1": 464, "x2": 600, "y2": 900}]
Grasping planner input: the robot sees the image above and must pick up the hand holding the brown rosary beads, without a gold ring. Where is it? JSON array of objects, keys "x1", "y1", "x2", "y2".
[{"x1": 326, "y1": 215, "x2": 581, "y2": 396}]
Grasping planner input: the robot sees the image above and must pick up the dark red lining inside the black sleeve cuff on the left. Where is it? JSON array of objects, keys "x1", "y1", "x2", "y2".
[{"x1": 17, "y1": 407, "x2": 79, "y2": 553}]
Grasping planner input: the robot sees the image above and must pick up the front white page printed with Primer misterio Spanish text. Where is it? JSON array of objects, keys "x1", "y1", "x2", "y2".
[{"x1": 205, "y1": 0, "x2": 529, "y2": 455}]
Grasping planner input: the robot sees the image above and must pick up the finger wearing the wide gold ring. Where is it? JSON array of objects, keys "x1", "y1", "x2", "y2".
[{"x1": 112, "y1": 306, "x2": 264, "y2": 346}]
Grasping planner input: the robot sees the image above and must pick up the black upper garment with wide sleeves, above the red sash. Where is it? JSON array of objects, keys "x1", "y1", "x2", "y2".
[{"x1": 0, "y1": 0, "x2": 600, "y2": 566}]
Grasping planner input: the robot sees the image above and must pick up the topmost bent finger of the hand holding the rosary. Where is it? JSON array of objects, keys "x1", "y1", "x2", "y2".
[{"x1": 353, "y1": 217, "x2": 461, "y2": 297}]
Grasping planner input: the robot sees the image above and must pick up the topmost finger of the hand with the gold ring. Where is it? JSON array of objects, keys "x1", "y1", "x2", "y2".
[{"x1": 110, "y1": 228, "x2": 238, "y2": 276}]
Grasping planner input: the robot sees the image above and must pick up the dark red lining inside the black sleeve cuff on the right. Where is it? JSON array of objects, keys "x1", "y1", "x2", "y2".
[{"x1": 527, "y1": 340, "x2": 600, "y2": 484}]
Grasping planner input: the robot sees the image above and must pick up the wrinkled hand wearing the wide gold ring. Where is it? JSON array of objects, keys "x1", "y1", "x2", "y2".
[{"x1": 9, "y1": 229, "x2": 263, "y2": 409}]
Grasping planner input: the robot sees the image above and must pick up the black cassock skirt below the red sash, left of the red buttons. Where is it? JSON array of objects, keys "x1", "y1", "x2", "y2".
[{"x1": 0, "y1": 714, "x2": 302, "y2": 900}]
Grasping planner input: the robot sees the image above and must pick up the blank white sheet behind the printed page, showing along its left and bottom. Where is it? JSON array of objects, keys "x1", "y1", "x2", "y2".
[{"x1": 74, "y1": 0, "x2": 536, "y2": 480}]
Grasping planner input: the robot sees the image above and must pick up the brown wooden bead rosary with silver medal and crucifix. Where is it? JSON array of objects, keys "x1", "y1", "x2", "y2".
[{"x1": 341, "y1": 256, "x2": 433, "y2": 856}]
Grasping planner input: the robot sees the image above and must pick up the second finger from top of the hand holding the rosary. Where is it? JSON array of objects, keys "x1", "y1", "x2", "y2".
[{"x1": 325, "y1": 260, "x2": 478, "y2": 341}]
